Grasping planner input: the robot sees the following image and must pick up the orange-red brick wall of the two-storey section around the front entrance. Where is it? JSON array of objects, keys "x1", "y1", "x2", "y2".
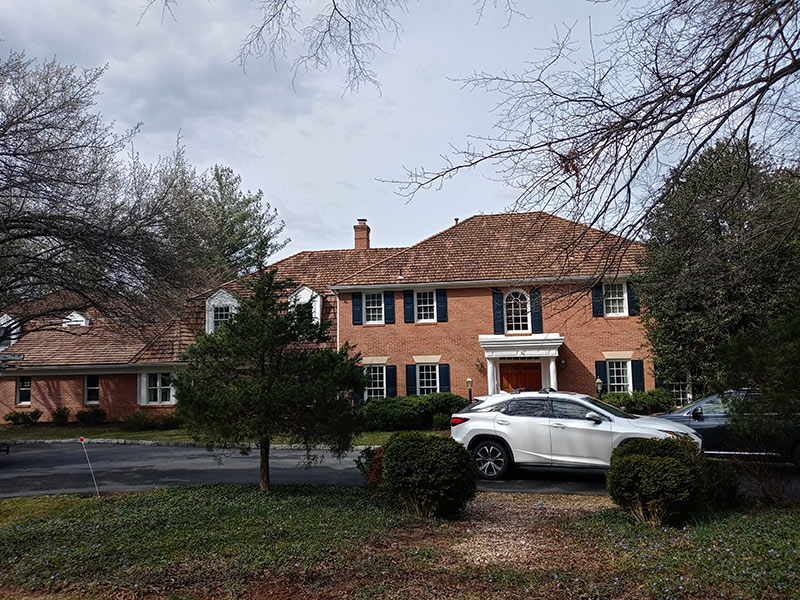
[{"x1": 340, "y1": 286, "x2": 655, "y2": 396}]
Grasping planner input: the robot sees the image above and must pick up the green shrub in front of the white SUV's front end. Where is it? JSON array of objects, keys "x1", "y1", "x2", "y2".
[{"x1": 606, "y1": 438, "x2": 739, "y2": 525}]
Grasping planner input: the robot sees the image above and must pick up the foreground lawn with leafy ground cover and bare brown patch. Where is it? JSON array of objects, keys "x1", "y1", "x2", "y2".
[{"x1": 0, "y1": 485, "x2": 800, "y2": 600}]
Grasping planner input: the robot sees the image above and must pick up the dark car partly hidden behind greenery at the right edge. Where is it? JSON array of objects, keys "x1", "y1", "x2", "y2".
[{"x1": 657, "y1": 390, "x2": 800, "y2": 467}]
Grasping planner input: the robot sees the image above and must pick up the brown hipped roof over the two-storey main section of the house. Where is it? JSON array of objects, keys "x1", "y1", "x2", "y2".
[{"x1": 336, "y1": 212, "x2": 643, "y2": 286}]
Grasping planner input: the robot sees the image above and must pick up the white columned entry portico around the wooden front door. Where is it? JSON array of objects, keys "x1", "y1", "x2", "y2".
[{"x1": 478, "y1": 333, "x2": 564, "y2": 394}]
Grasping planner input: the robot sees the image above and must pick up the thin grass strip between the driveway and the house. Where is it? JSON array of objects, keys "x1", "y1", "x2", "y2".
[{"x1": 0, "y1": 423, "x2": 392, "y2": 446}]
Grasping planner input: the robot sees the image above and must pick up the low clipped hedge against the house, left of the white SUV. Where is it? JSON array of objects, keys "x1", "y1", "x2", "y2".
[{"x1": 360, "y1": 392, "x2": 468, "y2": 431}]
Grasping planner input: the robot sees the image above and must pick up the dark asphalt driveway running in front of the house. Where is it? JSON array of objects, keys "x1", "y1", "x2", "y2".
[{"x1": 0, "y1": 442, "x2": 606, "y2": 498}]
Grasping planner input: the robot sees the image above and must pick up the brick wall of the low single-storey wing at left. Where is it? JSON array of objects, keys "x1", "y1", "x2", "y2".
[{"x1": 0, "y1": 373, "x2": 174, "y2": 422}]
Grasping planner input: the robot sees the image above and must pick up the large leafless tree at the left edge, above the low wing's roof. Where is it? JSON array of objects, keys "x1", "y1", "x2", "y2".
[{"x1": 0, "y1": 52, "x2": 234, "y2": 342}]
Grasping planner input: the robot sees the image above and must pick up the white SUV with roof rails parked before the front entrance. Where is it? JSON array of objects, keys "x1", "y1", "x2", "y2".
[{"x1": 450, "y1": 389, "x2": 702, "y2": 479}]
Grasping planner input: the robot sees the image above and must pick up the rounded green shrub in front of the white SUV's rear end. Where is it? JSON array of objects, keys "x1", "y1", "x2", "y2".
[{"x1": 382, "y1": 432, "x2": 477, "y2": 517}]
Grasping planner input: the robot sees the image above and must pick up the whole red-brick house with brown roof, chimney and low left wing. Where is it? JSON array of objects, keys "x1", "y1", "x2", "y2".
[{"x1": 0, "y1": 213, "x2": 655, "y2": 420}]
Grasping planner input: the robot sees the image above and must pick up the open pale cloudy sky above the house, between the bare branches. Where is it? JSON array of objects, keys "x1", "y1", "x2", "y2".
[{"x1": 0, "y1": 0, "x2": 616, "y2": 257}]
